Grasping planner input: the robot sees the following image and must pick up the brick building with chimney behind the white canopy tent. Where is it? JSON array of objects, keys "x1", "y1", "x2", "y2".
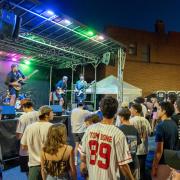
[{"x1": 101, "y1": 21, "x2": 180, "y2": 95}]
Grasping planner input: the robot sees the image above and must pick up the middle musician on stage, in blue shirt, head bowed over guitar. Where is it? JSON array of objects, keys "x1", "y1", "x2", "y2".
[{"x1": 56, "y1": 76, "x2": 68, "y2": 106}]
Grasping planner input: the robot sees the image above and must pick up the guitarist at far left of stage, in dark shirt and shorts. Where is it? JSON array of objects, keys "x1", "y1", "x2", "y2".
[{"x1": 5, "y1": 64, "x2": 27, "y2": 106}]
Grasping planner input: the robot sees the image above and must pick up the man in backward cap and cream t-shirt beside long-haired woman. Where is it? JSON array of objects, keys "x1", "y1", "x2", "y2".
[{"x1": 21, "y1": 106, "x2": 53, "y2": 180}]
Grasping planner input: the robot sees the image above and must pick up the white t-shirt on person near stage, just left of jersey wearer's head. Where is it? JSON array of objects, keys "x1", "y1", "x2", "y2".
[{"x1": 71, "y1": 108, "x2": 91, "y2": 133}]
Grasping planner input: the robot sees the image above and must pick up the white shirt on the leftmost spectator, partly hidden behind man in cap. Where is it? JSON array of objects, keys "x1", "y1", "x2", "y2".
[{"x1": 16, "y1": 111, "x2": 39, "y2": 156}]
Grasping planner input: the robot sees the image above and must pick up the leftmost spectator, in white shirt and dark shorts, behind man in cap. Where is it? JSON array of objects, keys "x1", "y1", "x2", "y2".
[{"x1": 16, "y1": 99, "x2": 39, "y2": 174}]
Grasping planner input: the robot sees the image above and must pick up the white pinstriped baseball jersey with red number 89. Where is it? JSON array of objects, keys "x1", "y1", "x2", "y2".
[{"x1": 82, "y1": 123, "x2": 132, "y2": 180}]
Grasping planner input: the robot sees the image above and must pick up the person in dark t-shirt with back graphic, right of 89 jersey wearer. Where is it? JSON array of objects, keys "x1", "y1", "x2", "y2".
[{"x1": 118, "y1": 108, "x2": 141, "y2": 180}]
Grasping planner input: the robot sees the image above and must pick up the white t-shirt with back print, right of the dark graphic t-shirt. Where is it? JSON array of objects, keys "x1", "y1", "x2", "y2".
[{"x1": 130, "y1": 116, "x2": 151, "y2": 155}]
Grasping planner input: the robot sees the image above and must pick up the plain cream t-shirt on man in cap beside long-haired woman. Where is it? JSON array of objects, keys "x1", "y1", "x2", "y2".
[{"x1": 21, "y1": 121, "x2": 52, "y2": 167}]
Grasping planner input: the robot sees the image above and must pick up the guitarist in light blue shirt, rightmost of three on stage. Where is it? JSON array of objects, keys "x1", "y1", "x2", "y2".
[{"x1": 75, "y1": 74, "x2": 87, "y2": 103}]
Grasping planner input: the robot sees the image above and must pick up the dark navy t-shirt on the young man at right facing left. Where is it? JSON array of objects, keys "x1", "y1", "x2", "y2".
[{"x1": 155, "y1": 120, "x2": 178, "y2": 164}]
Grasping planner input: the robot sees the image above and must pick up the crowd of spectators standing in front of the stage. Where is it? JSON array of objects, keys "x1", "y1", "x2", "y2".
[{"x1": 1, "y1": 94, "x2": 180, "y2": 180}]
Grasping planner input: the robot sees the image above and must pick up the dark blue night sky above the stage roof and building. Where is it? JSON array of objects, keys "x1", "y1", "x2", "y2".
[{"x1": 39, "y1": 0, "x2": 180, "y2": 31}]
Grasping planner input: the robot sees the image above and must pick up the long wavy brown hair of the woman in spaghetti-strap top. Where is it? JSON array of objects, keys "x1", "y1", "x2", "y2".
[{"x1": 43, "y1": 124, "x2": 67, "y2": 155}]
